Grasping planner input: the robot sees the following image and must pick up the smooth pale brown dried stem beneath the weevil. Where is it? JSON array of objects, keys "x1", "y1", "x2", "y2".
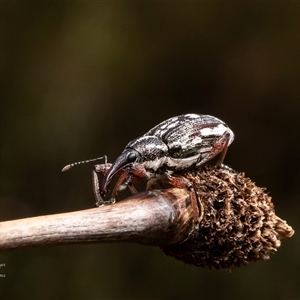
[{"x1": 0, "y1": 188, "x2": 194, "y2": 251}]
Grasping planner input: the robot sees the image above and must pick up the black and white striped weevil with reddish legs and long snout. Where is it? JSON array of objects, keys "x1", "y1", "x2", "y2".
[{"x1": 63, "y1": 114, "x2": 234, "y2": 206}]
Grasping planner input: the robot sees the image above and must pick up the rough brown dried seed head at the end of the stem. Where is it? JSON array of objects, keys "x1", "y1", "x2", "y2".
[{"x1": 161, "y1": 168, "x2": 294, "y2": 269}]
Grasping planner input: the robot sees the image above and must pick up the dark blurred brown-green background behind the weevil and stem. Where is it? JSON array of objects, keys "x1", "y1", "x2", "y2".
[{"x1": 0, "y1": 1, "x2": 300, "y2": 299}]
